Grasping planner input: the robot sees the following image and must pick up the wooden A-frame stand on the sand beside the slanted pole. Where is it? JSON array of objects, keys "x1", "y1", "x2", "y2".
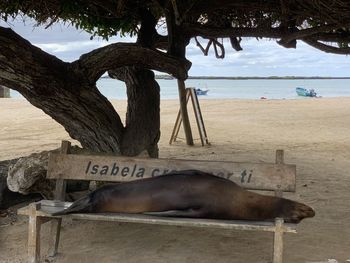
[{"x1": 169, "y1": 88, "x2": 210, "y2": 146}]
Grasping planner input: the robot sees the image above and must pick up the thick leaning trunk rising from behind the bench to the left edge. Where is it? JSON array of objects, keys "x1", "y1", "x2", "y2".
[{"x1": 0, "y1": 27, "x2": 124, "y2": 153}]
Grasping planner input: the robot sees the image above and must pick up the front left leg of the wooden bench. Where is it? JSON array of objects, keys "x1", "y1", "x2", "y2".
[{"x1": 28, "y1": 203, "x2": 41, "y2": 263}]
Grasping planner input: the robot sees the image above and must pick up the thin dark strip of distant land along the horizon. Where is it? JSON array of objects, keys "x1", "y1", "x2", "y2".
[{"x1": 102, "y1": 75, "x2": 350, "y2": 80}]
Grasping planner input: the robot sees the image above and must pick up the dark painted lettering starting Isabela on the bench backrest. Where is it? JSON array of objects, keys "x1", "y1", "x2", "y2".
[{"x1": 85, "y1": 161, "x2": 253, "y2": 183}]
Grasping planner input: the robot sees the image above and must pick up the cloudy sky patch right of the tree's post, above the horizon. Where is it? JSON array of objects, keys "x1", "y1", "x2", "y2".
[{"x1": 187, "y1": 38, "x2": 350, "y2": 76}]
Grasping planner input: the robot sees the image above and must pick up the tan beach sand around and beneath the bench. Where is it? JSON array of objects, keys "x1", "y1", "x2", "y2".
[{"x1": 0, "y1": 98, "x2": 350, "y2": 263}]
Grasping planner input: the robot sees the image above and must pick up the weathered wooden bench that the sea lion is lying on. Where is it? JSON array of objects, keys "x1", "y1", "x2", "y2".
[{"x1": 18, "y1": 141, "x2": 296, "y2": 263}]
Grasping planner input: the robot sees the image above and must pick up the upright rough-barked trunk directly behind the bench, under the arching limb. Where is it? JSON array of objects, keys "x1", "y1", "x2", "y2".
[{"x1": 109, "y1": 66, "x2": 160, "y2": 158}]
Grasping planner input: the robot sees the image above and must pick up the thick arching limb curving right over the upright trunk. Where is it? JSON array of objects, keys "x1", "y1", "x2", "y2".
[{"x1": 72, "y1": 43, "x2": 191, "y2": 81}]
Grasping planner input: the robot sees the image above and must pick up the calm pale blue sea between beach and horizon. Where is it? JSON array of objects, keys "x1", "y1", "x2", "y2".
[{"x1": 10, "y1": 78, "x2": 350, "y2": 100}]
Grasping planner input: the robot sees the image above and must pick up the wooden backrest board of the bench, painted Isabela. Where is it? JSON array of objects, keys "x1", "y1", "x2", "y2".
[{"x1": 47, "y1": 153, "x2": 296, "y2": 192}]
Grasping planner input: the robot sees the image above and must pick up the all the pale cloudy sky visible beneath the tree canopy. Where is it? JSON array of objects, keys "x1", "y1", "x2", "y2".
[{"x1": 0, "y1": 17, "x2": 350, "y2": 77}]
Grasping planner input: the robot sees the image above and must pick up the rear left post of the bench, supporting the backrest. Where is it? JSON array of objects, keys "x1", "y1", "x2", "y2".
[{"x1": 48, "y1": 141, "x2": 71, "y2": 257}]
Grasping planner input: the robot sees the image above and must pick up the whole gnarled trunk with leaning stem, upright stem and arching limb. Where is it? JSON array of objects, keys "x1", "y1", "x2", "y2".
[{"x1": 0, "y1": 23, "x2": 191, "y2": 157}]
